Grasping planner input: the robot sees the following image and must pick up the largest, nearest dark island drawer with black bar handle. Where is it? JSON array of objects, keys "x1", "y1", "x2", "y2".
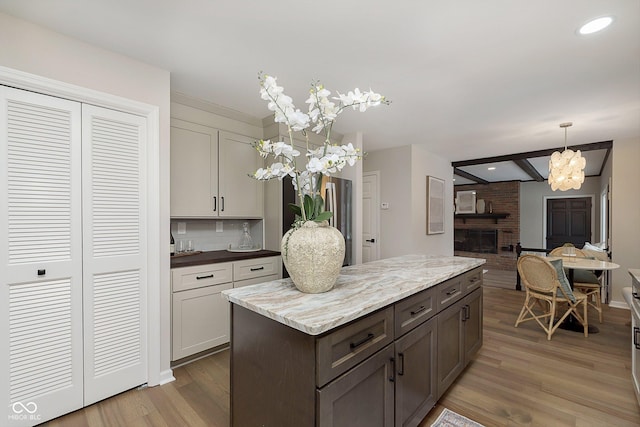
[{"x1": 316, "y1": 307, "x2": 393, "y2": 387}]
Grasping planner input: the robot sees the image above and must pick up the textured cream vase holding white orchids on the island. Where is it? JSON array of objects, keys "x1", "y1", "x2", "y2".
[{"x1": 280, "y1": 221, "x2": 344, "y2": 294}]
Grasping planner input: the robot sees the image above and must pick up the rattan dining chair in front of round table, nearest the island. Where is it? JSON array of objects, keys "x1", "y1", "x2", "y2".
[{"x1": 515, "y1": 255, "x2": 589, "y2": 340}]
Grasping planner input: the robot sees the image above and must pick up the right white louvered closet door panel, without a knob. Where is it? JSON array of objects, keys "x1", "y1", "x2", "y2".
[{"x1": 82, "y1": 105, "x2": 147, "y2": 405}]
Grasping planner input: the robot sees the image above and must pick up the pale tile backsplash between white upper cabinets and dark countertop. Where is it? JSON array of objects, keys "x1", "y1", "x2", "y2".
[{"x1": 171, "y1": 219, "x2": 264, "y2": 252}]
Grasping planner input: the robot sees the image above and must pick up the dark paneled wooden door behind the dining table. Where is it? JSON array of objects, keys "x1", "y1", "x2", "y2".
[{"x1": 547, "y1": 197, "x2": 591, "y2": 249}]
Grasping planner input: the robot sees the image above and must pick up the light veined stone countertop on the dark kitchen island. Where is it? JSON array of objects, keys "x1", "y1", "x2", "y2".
[{"x1": 222, "y1": 254, "x2": 485, "y2": 335}]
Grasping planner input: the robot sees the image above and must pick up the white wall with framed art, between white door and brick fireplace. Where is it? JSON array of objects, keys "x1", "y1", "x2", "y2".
[{"x1": 363, "y1": 145, "x2": 453, "y2": 258}]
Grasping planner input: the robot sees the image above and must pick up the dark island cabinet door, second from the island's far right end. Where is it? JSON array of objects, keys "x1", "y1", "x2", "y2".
[{"x1": 437, "y1": 300, "x2": 465, "y2": 399}]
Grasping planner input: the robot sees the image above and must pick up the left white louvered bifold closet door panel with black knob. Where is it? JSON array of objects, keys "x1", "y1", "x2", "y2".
[{"x1": 0, "y1": 86, "x2": 83, "y2": 426}]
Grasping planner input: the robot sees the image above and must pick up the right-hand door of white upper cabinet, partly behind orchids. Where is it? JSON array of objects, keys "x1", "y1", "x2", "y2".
[{"x1": 218, "y1": 132, "x2": 264, "y2": 218}]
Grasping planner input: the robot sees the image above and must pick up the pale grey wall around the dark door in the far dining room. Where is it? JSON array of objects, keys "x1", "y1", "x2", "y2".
[{"x1": 520, "y1": 177, "x2": 601, "y2": 248}]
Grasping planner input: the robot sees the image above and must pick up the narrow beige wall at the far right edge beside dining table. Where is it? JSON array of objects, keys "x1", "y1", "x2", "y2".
[{"x1": 611, "y1": 138, "x2": 640, "y2": 307}]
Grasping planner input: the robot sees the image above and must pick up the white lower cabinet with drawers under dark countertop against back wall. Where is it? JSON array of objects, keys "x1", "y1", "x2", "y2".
[{"x1": 171, "y1": 256, "x2": 282, "y2": 361}]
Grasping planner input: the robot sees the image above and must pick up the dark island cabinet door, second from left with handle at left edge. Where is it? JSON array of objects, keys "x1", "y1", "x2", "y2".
[{"x1": 395, "y1": 318, "x2": 437, "y2": 427}]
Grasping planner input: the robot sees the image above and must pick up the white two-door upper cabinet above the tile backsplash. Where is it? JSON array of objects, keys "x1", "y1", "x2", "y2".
[{"x1": 171, "y1": 119, "x2": 264, "y2": 218}]
